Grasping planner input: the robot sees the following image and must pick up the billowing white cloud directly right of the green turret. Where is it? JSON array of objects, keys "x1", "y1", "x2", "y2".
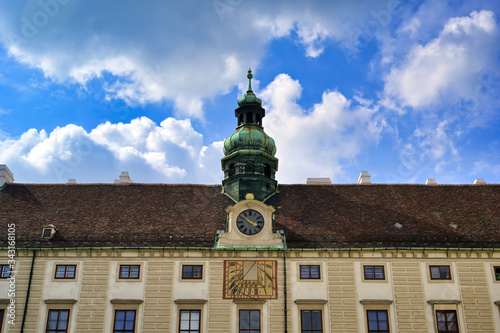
[{"x1": 259, "y1": 74, "x2": 384, "y2": 183}]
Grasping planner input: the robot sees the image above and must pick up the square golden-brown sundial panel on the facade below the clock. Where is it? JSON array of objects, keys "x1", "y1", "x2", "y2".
[{"x1": 223, "y1": 260, "x2": 278, "y2": 299}]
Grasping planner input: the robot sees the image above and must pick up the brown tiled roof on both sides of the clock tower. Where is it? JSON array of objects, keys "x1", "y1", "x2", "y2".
[{"x1": 0, "y1": 184, "x2": 500, "y2": 248}]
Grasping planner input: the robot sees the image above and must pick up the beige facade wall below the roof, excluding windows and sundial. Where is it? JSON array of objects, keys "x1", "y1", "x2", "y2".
[{"x1": 0, "y1": 248, "x2": 500, "y2": 333}]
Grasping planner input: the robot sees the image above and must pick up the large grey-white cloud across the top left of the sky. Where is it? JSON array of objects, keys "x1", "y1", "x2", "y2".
[{"x1": 0, "y1": 0, "x2": 402, "y2": 119}]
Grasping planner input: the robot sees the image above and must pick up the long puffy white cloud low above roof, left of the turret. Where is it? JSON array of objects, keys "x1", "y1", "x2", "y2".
[{"x1": 0, "y1": 117, "x2": 222, "y2": 183}]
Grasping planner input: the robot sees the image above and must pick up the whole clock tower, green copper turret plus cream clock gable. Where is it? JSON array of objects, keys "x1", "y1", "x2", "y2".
[{"x1": 217, "y1": 69, "x2": 284, "y2": 248}]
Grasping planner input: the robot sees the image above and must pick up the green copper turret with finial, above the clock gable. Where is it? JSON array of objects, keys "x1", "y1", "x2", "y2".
[{"x1": 221, "y1": 69, "x2": 278, "y2": 202}]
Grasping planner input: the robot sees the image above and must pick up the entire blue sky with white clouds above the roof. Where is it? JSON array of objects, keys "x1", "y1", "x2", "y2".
[{"x1": 0, "y1": 0, "x2": 500, "y2": 184}]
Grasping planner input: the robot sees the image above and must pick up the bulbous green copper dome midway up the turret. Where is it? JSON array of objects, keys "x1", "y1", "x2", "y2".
[{"x1": 223, "y1": 125, "x2": 276, "y2": 156}]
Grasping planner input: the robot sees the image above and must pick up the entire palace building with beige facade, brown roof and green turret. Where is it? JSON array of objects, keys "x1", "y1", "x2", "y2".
[{"x1": 0, "y1": 71, "x2": 500, "y2": 333}]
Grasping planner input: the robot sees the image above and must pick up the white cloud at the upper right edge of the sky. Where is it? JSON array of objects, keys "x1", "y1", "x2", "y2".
[{"x1": 384, "y1": 10, "x2": 500, "y2": 108}]
